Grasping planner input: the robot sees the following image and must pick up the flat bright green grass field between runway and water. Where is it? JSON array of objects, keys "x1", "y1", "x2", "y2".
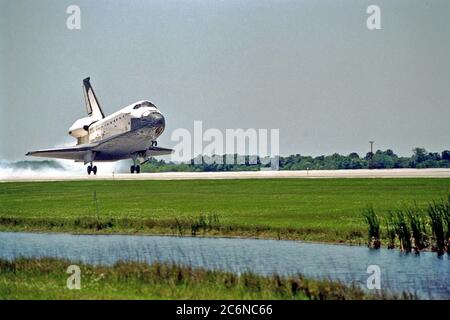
[{"x1": 0, "y1": 178, "x2": 450, "y2": 243}]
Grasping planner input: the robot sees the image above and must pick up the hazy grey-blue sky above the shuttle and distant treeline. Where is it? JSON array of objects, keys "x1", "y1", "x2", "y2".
[{"x1": 0, "y1": 0, "x2": 450, "y2": 160}]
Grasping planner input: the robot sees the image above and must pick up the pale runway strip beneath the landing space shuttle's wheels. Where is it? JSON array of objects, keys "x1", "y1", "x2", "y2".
[{"x1": 0, "y1": 169, "x2": 450, "y2": 182}]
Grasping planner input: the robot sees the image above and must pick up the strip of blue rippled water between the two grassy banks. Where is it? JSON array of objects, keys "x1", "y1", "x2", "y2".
[{"x1": 0, "y1": 232, "x2": 450, "y2": 299}]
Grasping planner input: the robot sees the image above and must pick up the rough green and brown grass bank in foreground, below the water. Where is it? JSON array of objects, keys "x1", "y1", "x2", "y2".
[{"x1": 0, "y1": 258, "x2": 398, "y2": 300}]
